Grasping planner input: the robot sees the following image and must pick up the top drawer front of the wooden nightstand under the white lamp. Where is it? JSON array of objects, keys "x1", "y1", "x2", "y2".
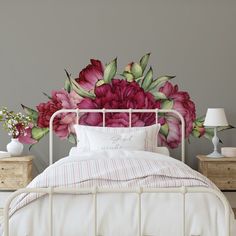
[{"x1": 207, "y1": 162, "x2": 236, "y2": 178}]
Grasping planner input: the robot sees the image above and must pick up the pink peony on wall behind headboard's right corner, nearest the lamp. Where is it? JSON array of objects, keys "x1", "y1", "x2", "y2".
[{"x1": 159, "y1": 82, "x2": 196, "y2": 148}]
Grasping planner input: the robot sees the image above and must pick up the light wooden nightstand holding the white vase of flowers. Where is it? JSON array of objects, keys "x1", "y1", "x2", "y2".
[{"x1": 0, "y1": 156, "x2": 33, "y2": 190}]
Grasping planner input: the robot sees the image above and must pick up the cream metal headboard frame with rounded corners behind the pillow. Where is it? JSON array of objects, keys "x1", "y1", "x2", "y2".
[{"x1": 49, "y1": 108, "x2": 185, "y2": 165}]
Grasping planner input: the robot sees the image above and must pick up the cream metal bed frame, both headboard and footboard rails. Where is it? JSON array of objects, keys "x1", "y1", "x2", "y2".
[{"x1": 4, "y1": 109, "x2": 230, "y2": 236}]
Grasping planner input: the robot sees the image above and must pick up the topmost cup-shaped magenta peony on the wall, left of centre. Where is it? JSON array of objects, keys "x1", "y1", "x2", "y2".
[{"x1": 75, "y1": 59, "x2": 104, "y2": 91}]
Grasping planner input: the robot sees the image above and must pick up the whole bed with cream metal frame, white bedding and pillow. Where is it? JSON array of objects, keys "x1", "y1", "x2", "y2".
[{"x1": 0, "y1": 109, "x2": 236, "y2": 236}]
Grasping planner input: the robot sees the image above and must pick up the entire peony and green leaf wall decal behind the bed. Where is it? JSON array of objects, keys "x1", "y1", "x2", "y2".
[{"x1": 19, "y1": 53, "x2": 232, "y2": 148}]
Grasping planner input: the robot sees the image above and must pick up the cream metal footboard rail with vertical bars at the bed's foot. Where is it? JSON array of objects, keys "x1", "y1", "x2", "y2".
[{"x1": 4, "y1": 186, "x2": 230, "y2": 236}]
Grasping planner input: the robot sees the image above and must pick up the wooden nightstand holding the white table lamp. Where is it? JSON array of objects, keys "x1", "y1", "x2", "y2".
[{"x1": 197, "y1": 155, "x2": 236, "y2": 190}]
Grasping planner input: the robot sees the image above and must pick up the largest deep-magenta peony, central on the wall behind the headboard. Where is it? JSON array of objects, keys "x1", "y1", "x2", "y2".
[{"x1": 79, "y1": 79, "x2": 160, "y2": 127}]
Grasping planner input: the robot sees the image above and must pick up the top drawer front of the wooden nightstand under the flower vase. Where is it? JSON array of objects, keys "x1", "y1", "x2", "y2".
[{"x1": 0, "y1": 163, "x2": 24, "y2": 177}]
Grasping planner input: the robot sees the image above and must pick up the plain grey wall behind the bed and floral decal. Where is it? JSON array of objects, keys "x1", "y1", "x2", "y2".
[{"x1": 0, "y1": 0, "x2": 236, "y2": 173}]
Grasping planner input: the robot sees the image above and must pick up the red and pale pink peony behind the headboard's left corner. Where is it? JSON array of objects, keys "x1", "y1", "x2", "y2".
[{"x1": 37, "y1": 89, "x2": 81, "y2": 138}]
